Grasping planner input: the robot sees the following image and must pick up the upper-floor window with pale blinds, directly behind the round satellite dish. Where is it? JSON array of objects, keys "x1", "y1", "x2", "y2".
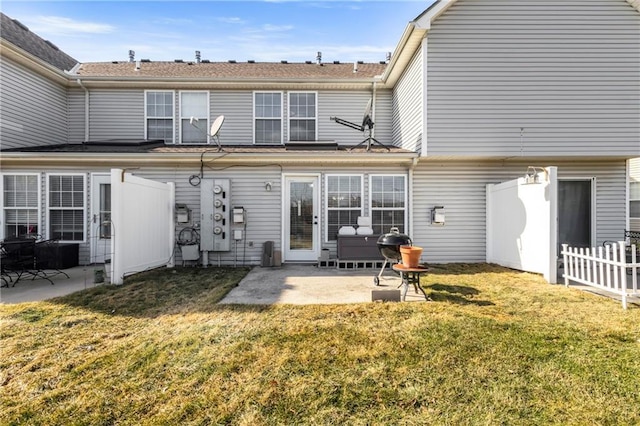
[{"x1": 180, "y1": 92, "x2": 209, "y2": 143}]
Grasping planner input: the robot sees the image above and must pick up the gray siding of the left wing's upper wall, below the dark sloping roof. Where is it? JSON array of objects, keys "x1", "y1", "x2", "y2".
[{"x1": 0, "y1": 58, "x2": 67, "y2": 149}]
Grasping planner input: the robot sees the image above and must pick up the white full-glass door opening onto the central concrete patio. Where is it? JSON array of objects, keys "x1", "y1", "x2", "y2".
[{"x1": 283, "y1": 175, "x2": 320, "y2": 262}]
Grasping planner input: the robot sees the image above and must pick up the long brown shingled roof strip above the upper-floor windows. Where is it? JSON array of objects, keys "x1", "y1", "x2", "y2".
[{"x1": 76, "y1": 61, "x2": 386, "y2": 80}]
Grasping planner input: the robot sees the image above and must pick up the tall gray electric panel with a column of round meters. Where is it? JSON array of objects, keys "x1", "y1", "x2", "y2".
[{"x1": 200, "y1": 179, "x2": 232, "y2": 251}]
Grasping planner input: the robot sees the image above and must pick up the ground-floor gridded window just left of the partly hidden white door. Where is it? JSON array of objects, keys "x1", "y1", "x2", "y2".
[{"x1": 47, "y1": 175, "x2": 85, "y2": 241}]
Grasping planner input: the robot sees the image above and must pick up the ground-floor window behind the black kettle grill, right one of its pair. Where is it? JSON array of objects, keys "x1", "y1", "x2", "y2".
[{"x1": 370, "y1": 175, "x2": 407, "y2": 234}]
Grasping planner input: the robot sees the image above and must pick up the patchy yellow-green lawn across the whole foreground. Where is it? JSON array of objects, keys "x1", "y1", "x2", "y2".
[{"x1": 0, "y1": 264, "x2": 640, "y2": 425}]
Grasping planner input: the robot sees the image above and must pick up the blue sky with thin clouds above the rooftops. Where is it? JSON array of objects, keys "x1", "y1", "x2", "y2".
[{"x1": 0, "y1": 0, "x2": 433, "y2": 62}]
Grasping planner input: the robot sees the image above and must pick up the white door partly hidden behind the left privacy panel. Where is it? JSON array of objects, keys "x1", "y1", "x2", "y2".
[{"x1": 89, "y1": 174, "x2": 111, "y2": 263}]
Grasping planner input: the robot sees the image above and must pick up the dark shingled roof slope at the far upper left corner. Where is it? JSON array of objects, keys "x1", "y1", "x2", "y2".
[{"x1": 0, "y1": 13, "x2": 78, "y2": 71}]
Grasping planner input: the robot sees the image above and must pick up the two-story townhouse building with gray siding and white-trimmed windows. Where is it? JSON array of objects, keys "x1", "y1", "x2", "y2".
[{"x1": 0, "y1": 0, "x2": 640, "y2": 282}]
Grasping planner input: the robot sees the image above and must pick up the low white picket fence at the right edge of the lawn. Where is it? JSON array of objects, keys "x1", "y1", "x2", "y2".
[{"x1": 562, "y1": 241, "x2": 640, "y2": 309}]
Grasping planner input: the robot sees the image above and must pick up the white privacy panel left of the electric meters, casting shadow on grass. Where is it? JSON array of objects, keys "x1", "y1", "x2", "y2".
[{"x1": 111, "y1": 169, "x2": 175, "y2": 284}]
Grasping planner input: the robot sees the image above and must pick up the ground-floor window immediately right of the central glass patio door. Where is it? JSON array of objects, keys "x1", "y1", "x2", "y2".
[{"x1": 326, "y1": 175, "x2": 362, "y2": 241}]
